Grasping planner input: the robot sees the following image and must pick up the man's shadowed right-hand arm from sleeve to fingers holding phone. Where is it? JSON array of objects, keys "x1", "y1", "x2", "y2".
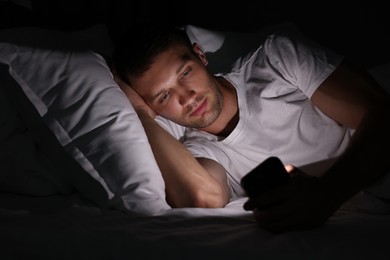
[{"x1": 244, "y1": 59, "x2": 390, "y2": 232}]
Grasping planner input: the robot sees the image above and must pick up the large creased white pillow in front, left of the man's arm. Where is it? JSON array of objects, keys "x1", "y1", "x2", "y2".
[{"x1": 0, "y1": 43, "x2": 170, "y2": 215}]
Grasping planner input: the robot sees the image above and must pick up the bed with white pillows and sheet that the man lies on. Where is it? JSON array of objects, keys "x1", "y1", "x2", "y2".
[{"x1": 0, "y1": 1, "x2": 390, "y2": 260}]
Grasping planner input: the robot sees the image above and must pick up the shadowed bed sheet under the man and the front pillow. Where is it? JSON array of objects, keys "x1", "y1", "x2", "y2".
[{"x1": 0, "y1": 193, "x2": 390, "y2": 260}]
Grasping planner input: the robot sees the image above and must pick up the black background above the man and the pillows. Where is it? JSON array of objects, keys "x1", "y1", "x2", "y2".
[{"x1": 0, "y1": 0, "x2": 390, "y2": 68}]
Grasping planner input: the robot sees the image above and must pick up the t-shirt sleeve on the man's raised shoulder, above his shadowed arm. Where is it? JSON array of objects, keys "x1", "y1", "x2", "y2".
[{"x1": 263, "y1": 34, "x2": 343, "y2": 98}]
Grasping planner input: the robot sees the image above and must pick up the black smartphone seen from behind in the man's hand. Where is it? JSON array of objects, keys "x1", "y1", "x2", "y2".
[{"x1": 241, "y1": 156, "x2": 290, "y2": 198}]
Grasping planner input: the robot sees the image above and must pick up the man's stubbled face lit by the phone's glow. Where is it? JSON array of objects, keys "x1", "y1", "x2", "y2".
[{"x1": 131, "y1": 46, "x2": 223, "y2": 128}]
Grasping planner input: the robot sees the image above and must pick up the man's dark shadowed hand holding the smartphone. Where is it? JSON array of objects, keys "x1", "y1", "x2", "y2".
[{"x1": 244, "y1": 168, "x2": 341, "y2": 233}]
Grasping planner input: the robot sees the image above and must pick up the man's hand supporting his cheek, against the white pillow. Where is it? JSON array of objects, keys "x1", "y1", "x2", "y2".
[{"x1": 113, "y1": 72, "x2": 156, "y2": 119}]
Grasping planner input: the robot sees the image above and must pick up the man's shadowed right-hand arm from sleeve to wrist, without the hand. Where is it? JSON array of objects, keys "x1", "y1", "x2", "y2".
[{"x1": 312, "y1": 62, "x2": 390, "y2": 198}]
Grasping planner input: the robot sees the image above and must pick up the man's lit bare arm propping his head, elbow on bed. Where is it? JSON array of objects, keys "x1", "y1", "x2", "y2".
[{"x1": 115, "y1": 74, "x2": 230, "y2": 208}]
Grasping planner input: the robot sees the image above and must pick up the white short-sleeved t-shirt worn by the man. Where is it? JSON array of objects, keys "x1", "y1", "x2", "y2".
[{"x1": 159, "y1": 34, "x2": 353, "y2": 197}]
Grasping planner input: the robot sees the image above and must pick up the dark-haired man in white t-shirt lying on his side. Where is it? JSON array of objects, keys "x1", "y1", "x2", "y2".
[{"x1": 114, "y1": 23, "x2": 390, "y2": 232}]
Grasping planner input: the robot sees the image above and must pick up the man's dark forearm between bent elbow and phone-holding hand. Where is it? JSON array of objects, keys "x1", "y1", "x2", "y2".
[{"x1": 322, "y1": 106, "x2": 390, "y2": 205}]
